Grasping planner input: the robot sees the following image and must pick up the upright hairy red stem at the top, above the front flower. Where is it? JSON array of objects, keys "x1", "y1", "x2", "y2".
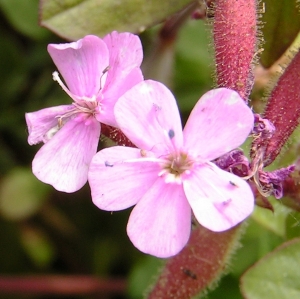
[{"x1": 213, "y1": 0, "x2": 257, "y2": 101}]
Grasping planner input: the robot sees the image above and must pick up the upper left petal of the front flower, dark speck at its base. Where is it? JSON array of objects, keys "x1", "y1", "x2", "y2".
[{"x1": 115, "y1": 80, "x2": 182, "y2": 154}]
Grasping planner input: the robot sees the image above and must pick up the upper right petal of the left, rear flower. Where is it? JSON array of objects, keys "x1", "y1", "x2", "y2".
[{"x1": 103, "y1": 31, "x2": 143, "y2": 98}]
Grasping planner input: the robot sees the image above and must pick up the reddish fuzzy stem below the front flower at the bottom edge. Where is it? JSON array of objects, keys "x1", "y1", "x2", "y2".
[{"x1": 147, "y1": 226, "x2": 240, "y2": 299}]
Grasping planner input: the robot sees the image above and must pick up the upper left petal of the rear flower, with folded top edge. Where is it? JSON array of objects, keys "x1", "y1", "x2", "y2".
[{"x1": 48, "y1": 35, "x2": 109, "y2": 97}]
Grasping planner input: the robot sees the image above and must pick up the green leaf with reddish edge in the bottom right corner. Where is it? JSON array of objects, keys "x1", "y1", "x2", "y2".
[{"x1": 241, "y1": 238, "x2": 300, "y2": 299}]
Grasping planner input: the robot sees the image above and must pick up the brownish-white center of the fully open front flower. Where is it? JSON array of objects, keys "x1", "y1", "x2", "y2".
[{"x1": 159, "y1": 152, "x2": 195, "y2": 184}]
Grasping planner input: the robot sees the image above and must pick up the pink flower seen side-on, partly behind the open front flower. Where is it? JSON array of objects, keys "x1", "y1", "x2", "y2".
[{"x1": 26, "y1": 32, "x2": 143, "y2": 192}]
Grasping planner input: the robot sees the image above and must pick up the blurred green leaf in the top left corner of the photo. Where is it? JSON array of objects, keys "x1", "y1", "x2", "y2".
[{"x1": 0, "y1": 0, "x2": 49, "y2": 39}]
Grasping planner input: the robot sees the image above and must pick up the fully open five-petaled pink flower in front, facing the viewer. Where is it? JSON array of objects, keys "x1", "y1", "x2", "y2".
[{"x1": 89, "y1": 81, "x2": 254, "y2": 257}]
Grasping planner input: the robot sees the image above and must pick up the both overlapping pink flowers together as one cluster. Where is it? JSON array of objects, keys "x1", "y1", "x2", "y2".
[{"x1": 26, "y1": 32, "x2": 254, "y2": 257}]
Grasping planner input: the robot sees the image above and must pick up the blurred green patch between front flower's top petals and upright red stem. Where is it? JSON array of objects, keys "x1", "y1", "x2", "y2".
[{"x1": 174, "y1": 20, "x2": 214, "y2": 119}]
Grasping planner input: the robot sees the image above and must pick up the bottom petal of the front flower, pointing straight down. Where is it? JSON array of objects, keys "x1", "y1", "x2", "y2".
[{"x1": 127, "y1": 178, "x2": 191, "y2": 258}]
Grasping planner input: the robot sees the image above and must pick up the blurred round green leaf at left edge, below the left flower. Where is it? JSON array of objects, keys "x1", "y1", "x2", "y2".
[{"x1": 0, "y1": 168, "x2": 49, "y2": 220}]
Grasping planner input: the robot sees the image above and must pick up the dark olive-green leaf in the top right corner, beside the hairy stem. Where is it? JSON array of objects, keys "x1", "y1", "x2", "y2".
[{"x1": 261, "y1": 0, "x2": 300, "y2": 68}]
